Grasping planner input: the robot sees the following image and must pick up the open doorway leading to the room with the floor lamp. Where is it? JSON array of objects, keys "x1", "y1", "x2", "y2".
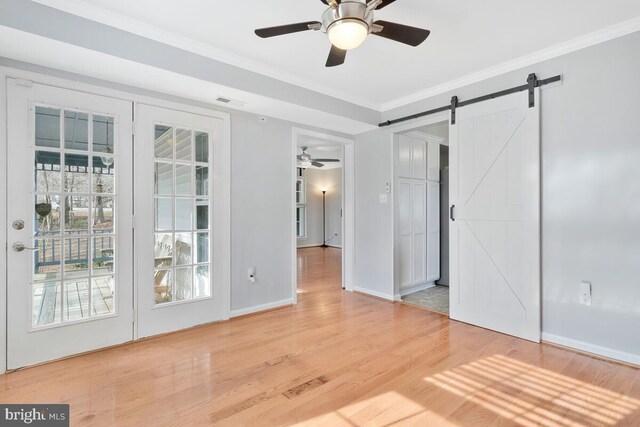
[{"x1": 293, "y1": 130, "x2": 353, "y2": 302}]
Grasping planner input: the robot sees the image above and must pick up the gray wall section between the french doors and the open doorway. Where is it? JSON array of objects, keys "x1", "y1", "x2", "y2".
[{"x1": 231, "y1": 114, "x2": 294, "y2": 312}]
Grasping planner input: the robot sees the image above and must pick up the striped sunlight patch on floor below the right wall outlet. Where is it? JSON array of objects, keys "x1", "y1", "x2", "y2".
[{"x1": 425, "y1": 355, "x2": 640, "y2": 427}]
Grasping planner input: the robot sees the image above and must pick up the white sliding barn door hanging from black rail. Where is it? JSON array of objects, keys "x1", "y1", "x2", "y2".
[{"x1": 450, "y1": 92, "x2": 541, "y2": 342}]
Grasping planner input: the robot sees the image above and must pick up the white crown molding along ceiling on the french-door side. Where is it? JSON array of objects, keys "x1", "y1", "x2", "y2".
[{"x1": 32, "y1": 0, "x2": 381, "y2": 111}]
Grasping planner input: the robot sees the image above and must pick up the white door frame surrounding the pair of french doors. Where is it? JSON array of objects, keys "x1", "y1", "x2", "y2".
[{"x1": 0, "y1": 66, "x2": 231, "y2": 375}]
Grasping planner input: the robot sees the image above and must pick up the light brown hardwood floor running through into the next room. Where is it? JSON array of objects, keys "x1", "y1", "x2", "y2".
[{"x1": 0, "y1": 248, "x2": 640, "y2": 426}]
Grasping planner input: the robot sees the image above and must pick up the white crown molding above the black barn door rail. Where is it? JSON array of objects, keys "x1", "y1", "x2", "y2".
[{"x1": 382, "y1": 16, "x2": 640, "y2": 113}]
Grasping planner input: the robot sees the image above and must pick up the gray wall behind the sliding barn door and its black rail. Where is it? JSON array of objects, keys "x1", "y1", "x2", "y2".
[{"x1": 364, "y1": 33, "x2": 640, "y2": 360}]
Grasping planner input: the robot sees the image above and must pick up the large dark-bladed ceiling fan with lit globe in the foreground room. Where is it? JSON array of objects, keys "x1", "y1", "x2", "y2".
[{"x1": 255, "y1": 0, "x2": 430, "y2": 67}]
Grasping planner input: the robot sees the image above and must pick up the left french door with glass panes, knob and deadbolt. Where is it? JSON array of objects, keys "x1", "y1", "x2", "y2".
[{"x1": 7, "y1": 79, "x2": 133, "y2": 369}]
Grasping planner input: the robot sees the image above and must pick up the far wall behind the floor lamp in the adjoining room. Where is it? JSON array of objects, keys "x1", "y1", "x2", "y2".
[{"x1": 298, "y1": 168, "x2": 342, "y2": 248}]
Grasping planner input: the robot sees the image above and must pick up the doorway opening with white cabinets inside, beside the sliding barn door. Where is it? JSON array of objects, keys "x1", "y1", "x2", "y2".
[{"x1": 394, "y1": 121, "x2": 449, "y2": 315}]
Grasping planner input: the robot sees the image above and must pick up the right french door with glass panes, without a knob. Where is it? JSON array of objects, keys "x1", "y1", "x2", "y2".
[{"x1": 135, "y1": 104, "x2": 228, "y2": 338}]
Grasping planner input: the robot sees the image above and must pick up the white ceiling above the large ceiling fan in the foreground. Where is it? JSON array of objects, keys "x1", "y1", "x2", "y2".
[{"x1": 31, "y1": 0, "x2": 640, "y2": 110}]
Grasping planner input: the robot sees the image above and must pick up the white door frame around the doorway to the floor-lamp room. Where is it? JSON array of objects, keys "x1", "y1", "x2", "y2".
[{"x1": 290, "y1": 127, "x2": 355, "y2": 304}]
